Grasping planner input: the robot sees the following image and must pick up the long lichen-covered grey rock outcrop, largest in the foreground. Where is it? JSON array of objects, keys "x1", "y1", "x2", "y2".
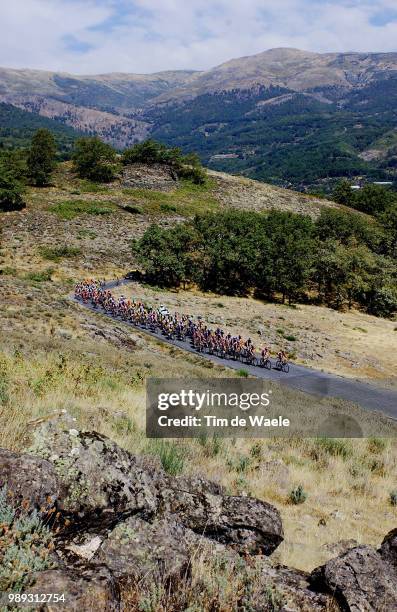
[{"x1": 30, "y1": 421, "x2": 283, "y2": 554}]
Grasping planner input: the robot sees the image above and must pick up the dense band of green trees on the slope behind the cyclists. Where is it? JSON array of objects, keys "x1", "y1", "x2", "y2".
[{"x1": 133, "y1": 208, "x2": 397, "y2": 318}]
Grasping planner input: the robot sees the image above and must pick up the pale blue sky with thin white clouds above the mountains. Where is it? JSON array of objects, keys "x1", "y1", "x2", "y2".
[{"x1": 0, "y1": 0, "x2": 397, "y2": 74}]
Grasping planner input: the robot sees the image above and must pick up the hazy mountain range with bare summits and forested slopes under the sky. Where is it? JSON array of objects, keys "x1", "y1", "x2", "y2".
[{"x1": 0, "y1": 49, "x2": 397, "y2": 188}]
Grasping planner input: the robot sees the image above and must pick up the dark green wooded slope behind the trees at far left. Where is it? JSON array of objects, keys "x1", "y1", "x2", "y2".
[{"x1": 0, "y1": 102, "x2": 81, "y2": 152}]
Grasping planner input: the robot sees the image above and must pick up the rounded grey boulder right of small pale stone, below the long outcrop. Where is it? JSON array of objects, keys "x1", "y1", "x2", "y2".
[{"x1": 94, "y1": 517, "x2": 191, "y2": 586}]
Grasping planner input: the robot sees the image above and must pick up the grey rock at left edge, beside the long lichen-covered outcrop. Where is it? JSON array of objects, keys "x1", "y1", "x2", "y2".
[{"x1": 0, "y1": 449, "x2": 60, "y2": 514}]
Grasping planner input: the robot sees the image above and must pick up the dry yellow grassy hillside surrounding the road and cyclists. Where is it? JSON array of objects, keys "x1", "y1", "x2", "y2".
[{"x1": 0, "y1": 164, "x2": 397, "y2": 569}]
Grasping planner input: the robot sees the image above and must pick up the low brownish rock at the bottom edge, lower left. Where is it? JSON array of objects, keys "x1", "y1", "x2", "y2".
[{"x1": 26, "y1": 567, "x2": 120, "y2": 612}]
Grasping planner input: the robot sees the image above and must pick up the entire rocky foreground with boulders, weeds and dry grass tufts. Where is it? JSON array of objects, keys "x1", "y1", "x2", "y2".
[{"x1": 0, "y1": 414, "x2": 397, "y2": 612}]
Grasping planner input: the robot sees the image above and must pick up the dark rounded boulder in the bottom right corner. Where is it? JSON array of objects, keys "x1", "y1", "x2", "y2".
[{"x1": 310, "y1": 546, "x2": 397, "y2": 612}]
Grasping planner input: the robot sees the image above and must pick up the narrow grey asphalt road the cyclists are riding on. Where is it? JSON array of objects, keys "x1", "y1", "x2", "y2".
[{"x1": 73, "y1": 280, "x2": 397, "y2": 420}]
